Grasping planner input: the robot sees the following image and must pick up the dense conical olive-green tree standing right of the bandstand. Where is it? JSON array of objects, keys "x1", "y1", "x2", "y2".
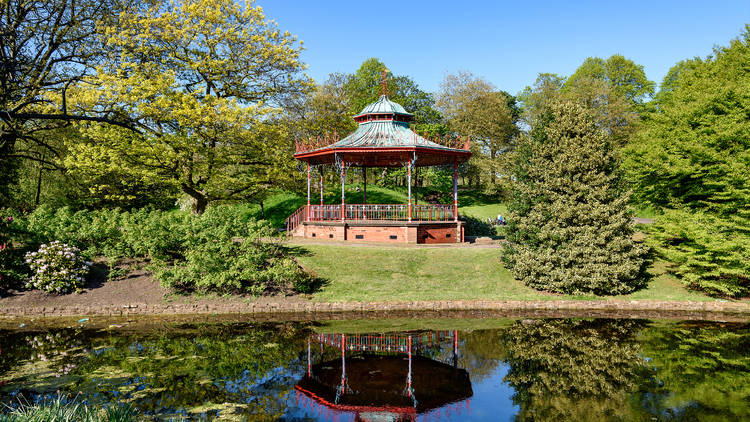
[{"x1": 504, "y1": 102, "x2": 646, "y2": 294}]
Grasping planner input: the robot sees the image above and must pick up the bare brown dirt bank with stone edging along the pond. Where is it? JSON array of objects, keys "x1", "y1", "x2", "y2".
[{"x1": 0, "y1": 272, "x2": 750, "y2": 327}]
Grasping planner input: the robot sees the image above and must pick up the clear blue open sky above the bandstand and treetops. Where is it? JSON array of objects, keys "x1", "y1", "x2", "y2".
[{"x1": 257, "y1": 0, "x2": 750, "y2": 94}]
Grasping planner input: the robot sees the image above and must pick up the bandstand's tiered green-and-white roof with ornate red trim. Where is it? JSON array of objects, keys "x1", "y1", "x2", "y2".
[{"x1": 294, "y1": 94, "x2": 471, "y2": 167}]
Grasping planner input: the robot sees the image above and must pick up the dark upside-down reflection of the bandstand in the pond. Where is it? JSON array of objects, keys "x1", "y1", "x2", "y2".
[{"x1": 295, "y1": 331, "x2": 473, "y2": 421}]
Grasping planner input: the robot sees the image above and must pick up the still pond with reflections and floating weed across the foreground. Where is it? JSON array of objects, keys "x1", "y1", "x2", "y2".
[{"x1": 0, "y1": 319, "x2": 750, "y2": 421}]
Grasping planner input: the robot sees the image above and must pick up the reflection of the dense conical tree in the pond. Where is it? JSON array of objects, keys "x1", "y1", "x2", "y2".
[{"x1": 502, "y1": 320, "x2": 647, "y2": 421}]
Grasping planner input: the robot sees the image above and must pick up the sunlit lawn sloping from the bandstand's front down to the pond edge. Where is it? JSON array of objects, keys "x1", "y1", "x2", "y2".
[{"x1": 292, "y1": 243, "x2": 713, "y2": 302}]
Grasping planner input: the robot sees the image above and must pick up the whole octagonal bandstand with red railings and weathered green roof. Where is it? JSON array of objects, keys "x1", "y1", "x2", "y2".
[{"x1": 286, "y1": 93, "x2": 471, "y2": 243}]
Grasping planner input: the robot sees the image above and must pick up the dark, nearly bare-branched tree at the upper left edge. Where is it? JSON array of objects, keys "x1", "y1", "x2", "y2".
[{"x1": 0, "y1": 0, "x2": 135, "y2": 203}]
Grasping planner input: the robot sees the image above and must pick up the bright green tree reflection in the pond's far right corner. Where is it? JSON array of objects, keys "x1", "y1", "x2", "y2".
[{"x1": 640, "y1": 323, "x2": 750, "y2": 421}]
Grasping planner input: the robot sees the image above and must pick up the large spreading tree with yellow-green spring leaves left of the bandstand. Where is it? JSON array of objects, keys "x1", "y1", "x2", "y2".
[{"x1": 66, "y1": 0, "x2": 310, "y2": 213}]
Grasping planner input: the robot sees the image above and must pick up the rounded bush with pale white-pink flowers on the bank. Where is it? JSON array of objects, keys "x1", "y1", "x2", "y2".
[{"x1": 26, "y1": 241, "x2": 91, "y2": 293}]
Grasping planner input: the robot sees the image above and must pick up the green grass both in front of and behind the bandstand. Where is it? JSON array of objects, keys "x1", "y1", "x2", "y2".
[{"x1": 268, "y1": 185, "x2": 711, "y2": 301}]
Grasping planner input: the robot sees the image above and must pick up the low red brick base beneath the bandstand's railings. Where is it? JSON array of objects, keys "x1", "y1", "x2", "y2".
[{"x1": 294, "y1": 220, "x2": 464, "y2": 244}]
